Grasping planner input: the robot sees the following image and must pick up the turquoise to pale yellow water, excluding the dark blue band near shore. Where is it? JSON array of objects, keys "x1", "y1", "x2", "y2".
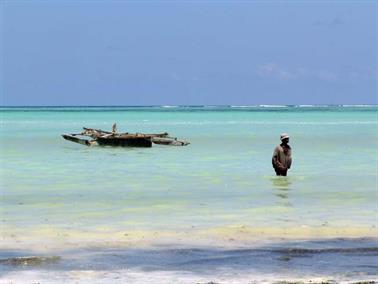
[{"x1": 0, "y1": 107, "x2": 378, "y2": 242}]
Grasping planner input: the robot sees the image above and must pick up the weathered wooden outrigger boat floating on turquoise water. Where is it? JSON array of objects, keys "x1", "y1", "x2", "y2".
[{"x1": 62, "y1": 124, "x2": 190, "y2": 147}]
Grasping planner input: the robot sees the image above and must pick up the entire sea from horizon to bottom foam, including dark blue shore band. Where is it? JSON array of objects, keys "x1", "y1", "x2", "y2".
[{"x1": 0, "y1": 106, "x2": 378, "y2": 283}]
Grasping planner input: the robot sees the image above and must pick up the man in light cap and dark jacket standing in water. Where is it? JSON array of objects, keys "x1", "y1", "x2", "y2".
[{"x1": 272, "y1": 133, "x2": 291, "y2": 176}]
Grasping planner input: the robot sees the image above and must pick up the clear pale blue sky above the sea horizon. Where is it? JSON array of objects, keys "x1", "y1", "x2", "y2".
[{"x1": 0, "y1": 0, "x2": 378, "y2": 106}]
